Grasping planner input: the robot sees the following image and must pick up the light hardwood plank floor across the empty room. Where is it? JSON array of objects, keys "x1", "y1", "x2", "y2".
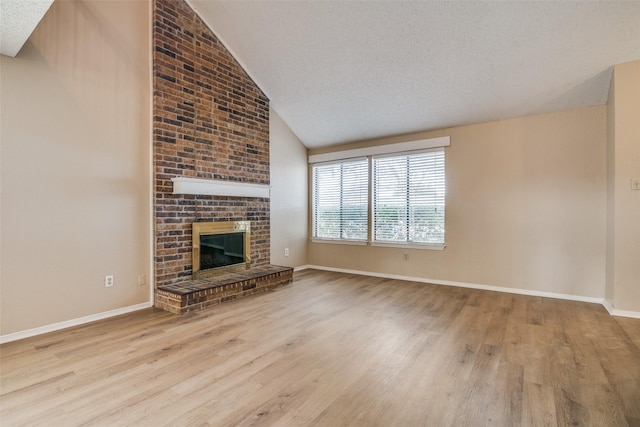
[{"x1": 0, "y1": 270, "x2": 640, "y2": 426}]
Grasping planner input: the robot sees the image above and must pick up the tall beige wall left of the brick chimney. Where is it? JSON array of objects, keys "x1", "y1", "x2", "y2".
[{"x1": 0, "y1": 1, "x2": 151, "y2": 335}]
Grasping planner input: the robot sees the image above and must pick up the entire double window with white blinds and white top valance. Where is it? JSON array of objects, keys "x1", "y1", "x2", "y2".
[{"x1": 309, "y1": 137, "x2": 449, "y2": 249}]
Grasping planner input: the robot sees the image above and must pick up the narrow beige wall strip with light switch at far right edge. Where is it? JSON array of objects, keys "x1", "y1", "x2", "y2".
[{"x1": 607, "y1": 61, "x2": 640, "y2": 312}]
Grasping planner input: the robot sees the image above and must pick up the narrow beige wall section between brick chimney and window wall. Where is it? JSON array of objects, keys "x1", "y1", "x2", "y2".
[{"x1": 269, "y1": 109, "x2": 308, "y2": 267}]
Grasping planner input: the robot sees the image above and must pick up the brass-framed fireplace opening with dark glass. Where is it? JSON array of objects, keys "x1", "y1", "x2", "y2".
[{"x1": 192, "y1": 221, "x2": 251, "y2": 279}]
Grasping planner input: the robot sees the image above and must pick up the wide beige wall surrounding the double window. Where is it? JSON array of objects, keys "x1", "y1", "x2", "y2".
[{"x1": 309, "y1": 106, "x2": 607, "y2": 298}]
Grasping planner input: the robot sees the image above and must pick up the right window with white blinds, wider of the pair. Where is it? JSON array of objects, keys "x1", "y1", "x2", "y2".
[{"x1": 372, "y1": 149, "x2": 445, "y2": 245}]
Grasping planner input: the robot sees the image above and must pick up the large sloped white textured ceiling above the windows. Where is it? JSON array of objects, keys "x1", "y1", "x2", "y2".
[{"x1": 188, "y1": 0, "x2": 640, "y2": 148}]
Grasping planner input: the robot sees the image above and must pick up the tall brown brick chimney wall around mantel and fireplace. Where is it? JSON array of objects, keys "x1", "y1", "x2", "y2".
[{"x1": 153, "y1": 0, "x2": 270, "y2": 286}]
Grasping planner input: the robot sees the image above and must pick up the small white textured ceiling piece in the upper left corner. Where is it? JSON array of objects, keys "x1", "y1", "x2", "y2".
[{"x1": 0, "y1": 0, "x2": 53, "y2": 56}]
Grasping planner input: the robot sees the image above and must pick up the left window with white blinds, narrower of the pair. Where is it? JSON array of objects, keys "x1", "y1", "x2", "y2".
[{"x1": 313, "y1": 158, "x2": 369, "y2": 241}]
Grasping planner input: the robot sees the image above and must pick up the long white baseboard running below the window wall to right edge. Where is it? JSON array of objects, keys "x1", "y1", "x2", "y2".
[{"x1": 298, "y1": 265, "x2": 640, "y2": 319}]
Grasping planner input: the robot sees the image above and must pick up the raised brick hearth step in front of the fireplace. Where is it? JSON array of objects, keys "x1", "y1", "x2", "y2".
[{"x1": 155, "y1": 265, "x2": 293, "y2": 314}]
